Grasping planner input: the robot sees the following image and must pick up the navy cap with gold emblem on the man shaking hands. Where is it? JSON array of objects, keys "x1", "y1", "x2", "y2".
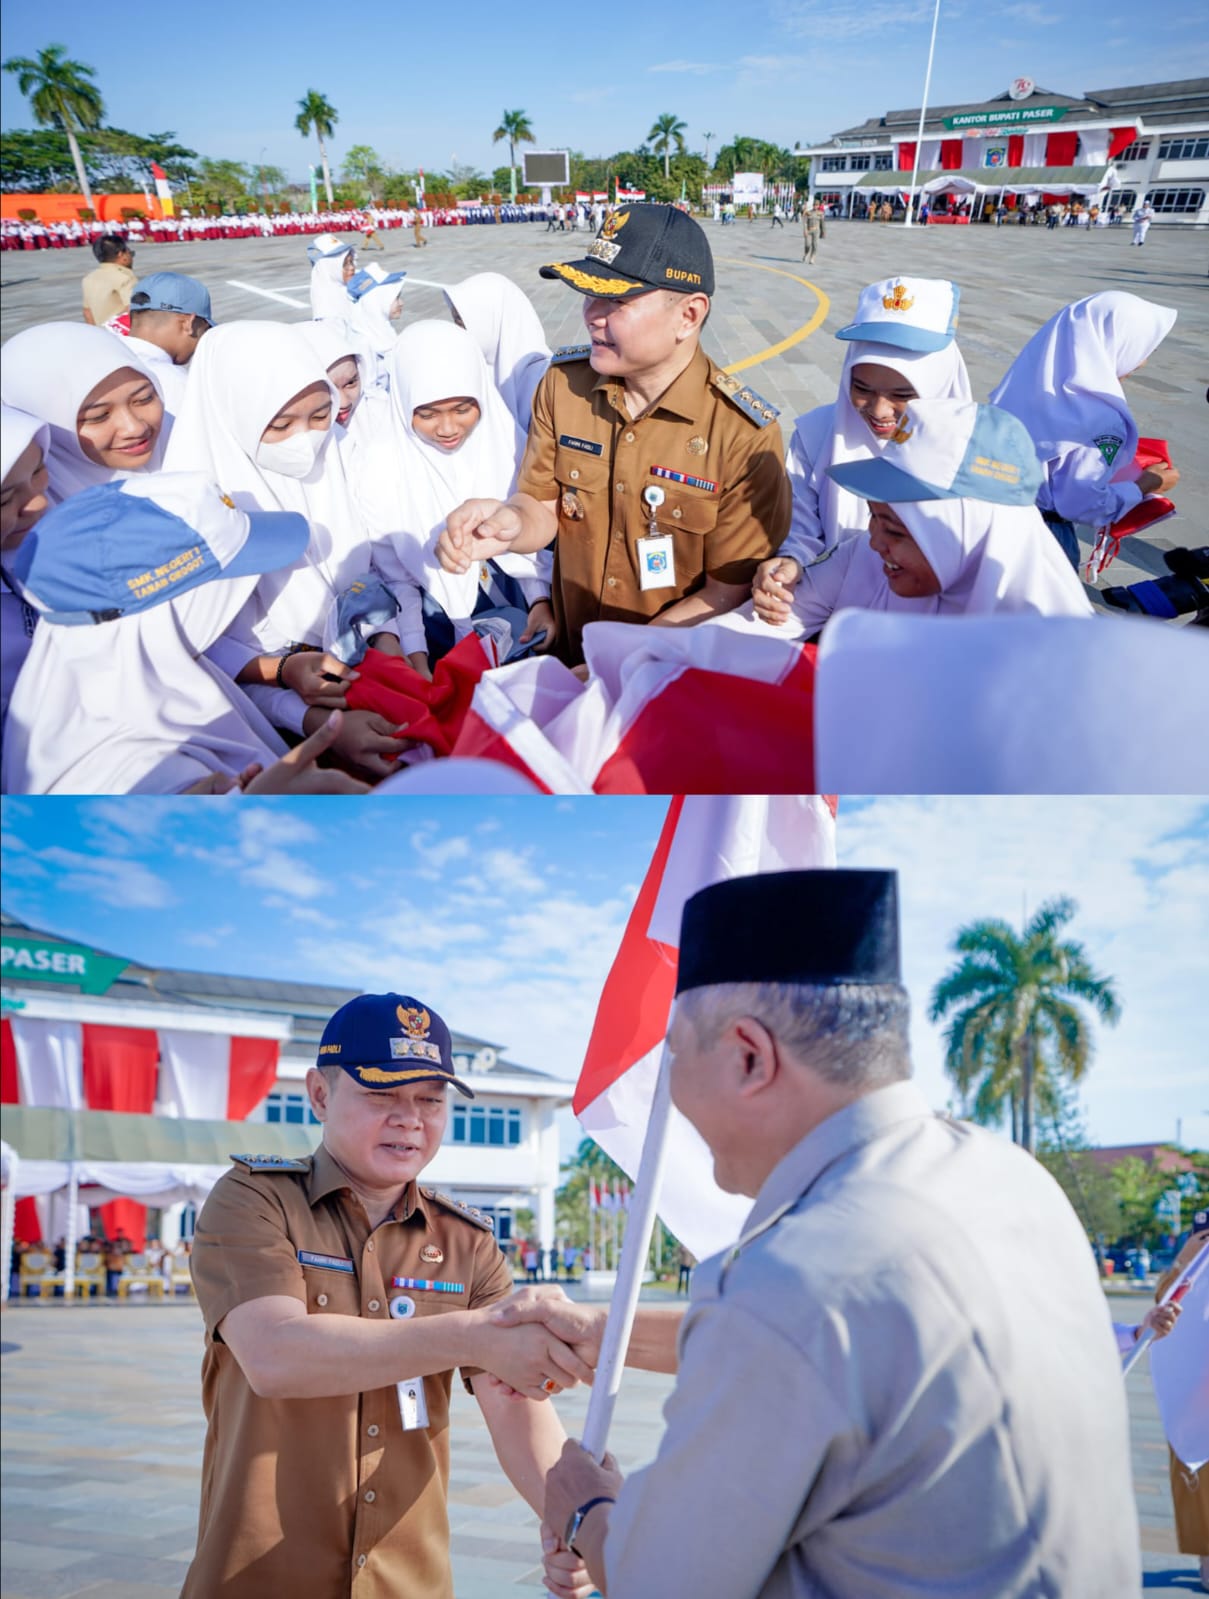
[{"x1": 315, "y1": 995, "x2": 475, "y2": 1099}]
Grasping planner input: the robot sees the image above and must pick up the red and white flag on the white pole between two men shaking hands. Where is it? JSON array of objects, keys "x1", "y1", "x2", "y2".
[{"x1": 573, "y1": 795, "x2": 835, "y2": 1260}]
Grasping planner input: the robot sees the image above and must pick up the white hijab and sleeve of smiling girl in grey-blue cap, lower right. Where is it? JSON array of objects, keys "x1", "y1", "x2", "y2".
[{"x1": 798, "y1": 499, "x2": 1092, "y2": 632}]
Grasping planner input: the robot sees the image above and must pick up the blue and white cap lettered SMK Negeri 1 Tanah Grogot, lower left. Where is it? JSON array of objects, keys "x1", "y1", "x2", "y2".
[{"x1": 8, "y1": 472, "x2": 310, "y2": 627}]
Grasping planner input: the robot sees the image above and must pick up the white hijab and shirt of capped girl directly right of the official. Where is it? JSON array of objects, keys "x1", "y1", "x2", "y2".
[{"x1": 777, "y1": 341, "x2": 974, "y2": 566}]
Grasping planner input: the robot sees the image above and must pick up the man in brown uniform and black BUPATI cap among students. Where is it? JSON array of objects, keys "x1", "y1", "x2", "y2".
[{"x1": 438, "y1": 205, "x2": 790, "y2": 665}]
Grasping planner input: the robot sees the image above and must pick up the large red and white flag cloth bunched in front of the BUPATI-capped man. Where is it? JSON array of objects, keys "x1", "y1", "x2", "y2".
[{"x1": 453, "y1": 622, "x2": 816, "y2": 795}]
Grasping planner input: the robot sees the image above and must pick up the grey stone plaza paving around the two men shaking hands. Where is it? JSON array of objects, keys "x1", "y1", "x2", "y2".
[{"x1": 0, "y1": 1295, "x2": 1201, "y2": 1599}]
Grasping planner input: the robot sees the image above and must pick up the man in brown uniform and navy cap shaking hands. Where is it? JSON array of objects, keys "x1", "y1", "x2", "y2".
[{"x1": 182, "y1": 995, "x2": 590, "y2": 1599}]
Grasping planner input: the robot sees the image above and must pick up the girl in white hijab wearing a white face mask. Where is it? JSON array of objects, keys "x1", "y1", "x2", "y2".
[{"x1": 168, "y1": 321, "x2": 398, "y2": 776}]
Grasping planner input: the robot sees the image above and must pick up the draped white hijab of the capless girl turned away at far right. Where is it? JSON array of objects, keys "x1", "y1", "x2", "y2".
[{"x1": 990, "y1": 289, "x2": 1177, "y2": 477}]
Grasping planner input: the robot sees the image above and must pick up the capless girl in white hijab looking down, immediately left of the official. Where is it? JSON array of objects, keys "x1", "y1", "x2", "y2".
[{"x1": 357, "y1": 321, "x2": 553, "y2": 676}]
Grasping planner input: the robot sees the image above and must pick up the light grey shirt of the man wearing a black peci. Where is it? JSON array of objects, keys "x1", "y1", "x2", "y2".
[{"x1": 605, "y1": 1083, "x2": 1142, "y2": 1599}]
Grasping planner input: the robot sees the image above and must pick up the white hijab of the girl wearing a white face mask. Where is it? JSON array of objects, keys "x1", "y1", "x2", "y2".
[{"x1": 166, "y1": 321, "x2": 368, "y2": 654}]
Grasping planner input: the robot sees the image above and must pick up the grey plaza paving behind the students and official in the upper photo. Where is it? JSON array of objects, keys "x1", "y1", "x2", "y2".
[{"x1": 0, "y1": 219, "x2": 1209, "y2": 584}]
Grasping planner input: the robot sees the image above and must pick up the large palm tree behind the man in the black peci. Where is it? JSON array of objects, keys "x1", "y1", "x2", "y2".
[{"x1": 928, "y1": 899, "x2": 1121, "y2": 1154}]
